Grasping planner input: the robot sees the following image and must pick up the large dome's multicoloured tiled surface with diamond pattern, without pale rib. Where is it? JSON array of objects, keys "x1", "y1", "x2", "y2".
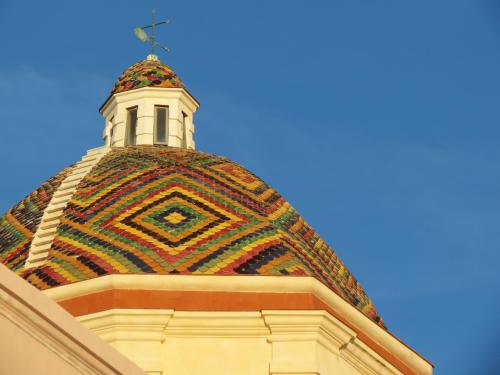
[{"x1": 0, "y1": 146, "x2": 383, "y2": 326}]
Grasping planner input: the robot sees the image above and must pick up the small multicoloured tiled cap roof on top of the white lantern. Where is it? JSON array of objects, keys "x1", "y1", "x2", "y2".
[{"x1": 110, "y1": 60, "x2": 184, "y2": 95}]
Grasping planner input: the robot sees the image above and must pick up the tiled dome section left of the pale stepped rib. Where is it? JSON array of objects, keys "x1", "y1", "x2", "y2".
[{"x1": 0, "y1": 167, "x2": 71, "y2": 272}]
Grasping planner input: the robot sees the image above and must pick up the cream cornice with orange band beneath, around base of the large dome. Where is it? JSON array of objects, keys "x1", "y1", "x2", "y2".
[{"x1": 44, "y1": 275, "x2": 432, "y2": 374}]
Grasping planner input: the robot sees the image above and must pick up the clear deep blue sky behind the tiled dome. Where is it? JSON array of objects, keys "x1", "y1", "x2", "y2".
[{"x1": 0, "y1": 0, "x2": 500, "y2": 375}]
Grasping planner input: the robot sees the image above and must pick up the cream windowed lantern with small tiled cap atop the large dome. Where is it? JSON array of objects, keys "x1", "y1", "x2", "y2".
[{"x1": 99, "y1": 54, "x2": 199, "y2": 149}]
